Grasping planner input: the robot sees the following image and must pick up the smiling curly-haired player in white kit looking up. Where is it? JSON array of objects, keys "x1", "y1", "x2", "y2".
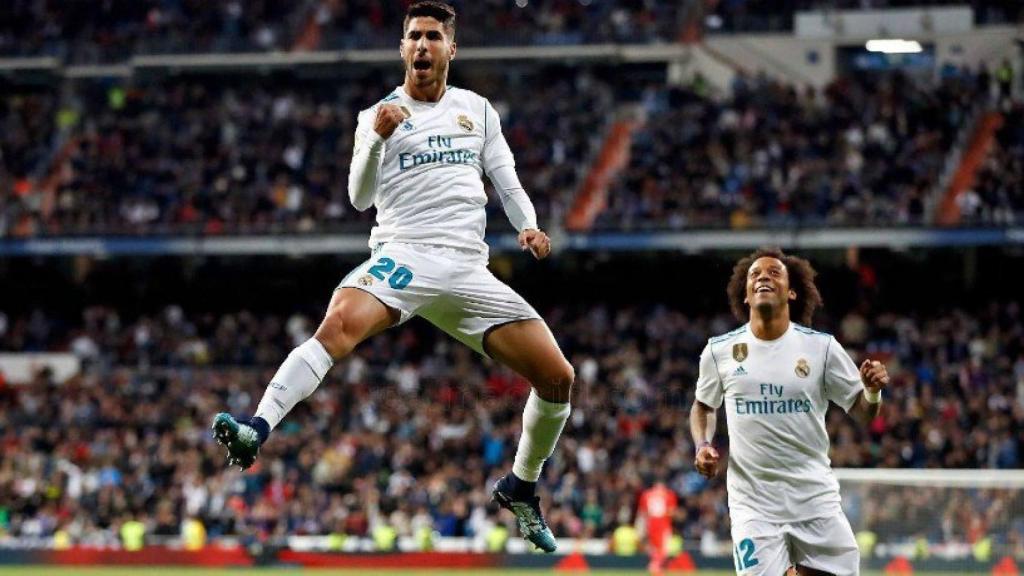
[{"x1": 690, "y1": 250, "x2": 889, "y2": 576}]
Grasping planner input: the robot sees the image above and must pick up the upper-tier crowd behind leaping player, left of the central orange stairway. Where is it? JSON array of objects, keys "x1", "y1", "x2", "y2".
[{"x1": 0, "y1": 68, "x2": 614, "y2": 237}]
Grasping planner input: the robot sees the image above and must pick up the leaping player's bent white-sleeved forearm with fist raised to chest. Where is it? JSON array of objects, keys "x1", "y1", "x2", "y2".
[{"x1": 348, "y1": 105, "x2": 406, "y2": 212}]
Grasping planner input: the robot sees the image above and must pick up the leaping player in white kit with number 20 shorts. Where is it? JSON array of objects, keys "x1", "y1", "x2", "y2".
[{"x1": 213, "y1": 1, "x2": 574, "y2": 552}]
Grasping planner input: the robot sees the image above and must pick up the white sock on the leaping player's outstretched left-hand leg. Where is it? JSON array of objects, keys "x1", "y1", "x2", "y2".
[{"x1": 256, "y1": 338, "x2": 334, "y2": 429}]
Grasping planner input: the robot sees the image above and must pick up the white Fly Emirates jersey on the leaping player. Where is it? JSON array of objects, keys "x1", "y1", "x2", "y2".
[{"x1": 353, "y1": 86, "x2": 515, "y2": 257}]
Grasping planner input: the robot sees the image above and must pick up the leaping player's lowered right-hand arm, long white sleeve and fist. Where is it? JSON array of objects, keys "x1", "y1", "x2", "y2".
[{"x1": 481, "y1": 102, "x2": 551, "y2": 259}]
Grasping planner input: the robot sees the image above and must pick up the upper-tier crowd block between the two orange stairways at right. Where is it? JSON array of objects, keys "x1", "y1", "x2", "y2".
[{"x1": 599, "y1": 68, "x2": 995, "y2": 229}]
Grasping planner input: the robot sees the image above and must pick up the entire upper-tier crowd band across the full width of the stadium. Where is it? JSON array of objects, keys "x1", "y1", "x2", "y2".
[{"x1": 8, "y1": 66, "x2": 1024, "y2": 238}]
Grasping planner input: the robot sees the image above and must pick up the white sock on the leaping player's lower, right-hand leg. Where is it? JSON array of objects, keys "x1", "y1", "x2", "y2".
[{"x1": 512, "y1": 390, "x2": 569, "y2": 482}]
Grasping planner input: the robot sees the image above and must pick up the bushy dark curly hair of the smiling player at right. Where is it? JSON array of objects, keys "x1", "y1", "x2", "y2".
[{"x1": 725, "y1": 248, "x2": 822, "y2": 326}]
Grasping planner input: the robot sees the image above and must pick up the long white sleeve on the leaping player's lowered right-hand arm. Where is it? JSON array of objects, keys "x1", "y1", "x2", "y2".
[{"x1": 480, "y1": 99, "x2": 538, "y2": 232}]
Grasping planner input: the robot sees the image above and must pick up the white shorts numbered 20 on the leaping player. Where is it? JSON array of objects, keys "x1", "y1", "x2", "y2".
[{"x1": 338, "y1": 242, "x2": 541, "y2": 356}]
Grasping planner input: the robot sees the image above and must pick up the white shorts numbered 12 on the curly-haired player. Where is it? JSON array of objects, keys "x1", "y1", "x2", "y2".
[{"x1": 732, "y1": 511, "x2": 860, "y2": 576}]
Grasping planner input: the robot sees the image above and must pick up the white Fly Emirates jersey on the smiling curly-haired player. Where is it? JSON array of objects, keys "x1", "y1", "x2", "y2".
[{"x1": 696, "y1": 323, "x2": 864, "y2": 525}]
